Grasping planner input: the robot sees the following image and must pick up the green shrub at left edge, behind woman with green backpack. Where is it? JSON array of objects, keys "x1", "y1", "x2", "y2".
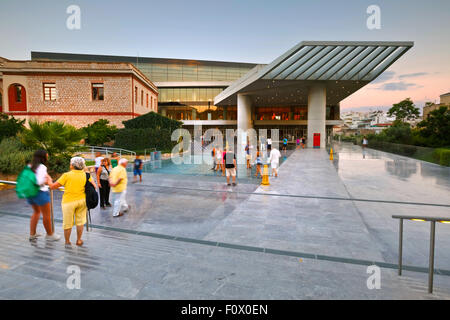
[{"x1": 0, "y1": 137, "x2": 33, "y2": 174}]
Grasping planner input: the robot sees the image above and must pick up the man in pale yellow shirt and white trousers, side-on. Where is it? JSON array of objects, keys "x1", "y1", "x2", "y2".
[{"x1": 109, "y1": 158, "x2": 130, "y2": 217}]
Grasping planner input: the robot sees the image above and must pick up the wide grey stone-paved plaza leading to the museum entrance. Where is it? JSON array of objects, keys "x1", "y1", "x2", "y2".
[{"x1": 0, "y1": 144, "x2": 450, "y2": 299}]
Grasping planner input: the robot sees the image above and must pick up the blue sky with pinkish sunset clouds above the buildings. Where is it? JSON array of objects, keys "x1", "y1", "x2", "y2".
[{"x1": 0, "y1": 0, "x2": 450, "y2": 110}]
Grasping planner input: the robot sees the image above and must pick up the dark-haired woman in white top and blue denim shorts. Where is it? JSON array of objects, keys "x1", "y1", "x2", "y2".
[{"x1": 27, "y1": 150, "x2": 61, "y2": 241}]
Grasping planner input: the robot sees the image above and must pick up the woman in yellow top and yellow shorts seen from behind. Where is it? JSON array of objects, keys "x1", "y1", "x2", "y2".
[{"x1": 49, "y1": 157, "x2": 97, "y2": 246}]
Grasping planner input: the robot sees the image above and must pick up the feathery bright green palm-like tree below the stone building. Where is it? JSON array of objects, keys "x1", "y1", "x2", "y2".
[{"x1": 20, "y1": 120, "x2": 84, "y2": 156}]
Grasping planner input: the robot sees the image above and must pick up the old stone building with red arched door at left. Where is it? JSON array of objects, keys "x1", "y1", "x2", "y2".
[{"x1": 0, "y1": 58, "x2": 158, "y2": 127}]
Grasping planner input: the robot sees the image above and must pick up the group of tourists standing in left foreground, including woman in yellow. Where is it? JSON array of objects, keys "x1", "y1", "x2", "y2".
[{"x1": 22, "y1": 150, "x2": 143, "y2": 247}]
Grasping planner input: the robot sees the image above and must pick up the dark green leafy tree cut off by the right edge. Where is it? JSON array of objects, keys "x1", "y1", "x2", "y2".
[{"x1": 417, "y1": 105, "x2": 450, "y2": 147}]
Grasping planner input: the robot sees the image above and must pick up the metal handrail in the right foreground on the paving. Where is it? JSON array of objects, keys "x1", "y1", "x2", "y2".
[{"x1": 392, "y1": 215, "x2": 450, "y2": 293}]
